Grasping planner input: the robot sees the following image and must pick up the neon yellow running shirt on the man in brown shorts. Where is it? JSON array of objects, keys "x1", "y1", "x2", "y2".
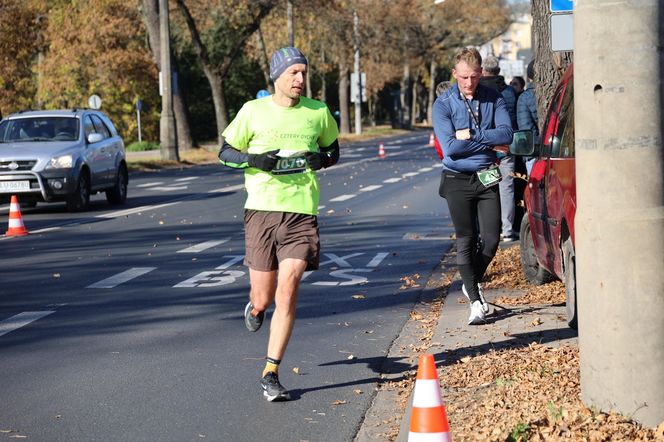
[{"x1": 222, "y1": 96, "x2": 339, "y2": 215}]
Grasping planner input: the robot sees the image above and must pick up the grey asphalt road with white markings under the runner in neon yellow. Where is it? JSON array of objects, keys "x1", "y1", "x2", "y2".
[{"x1": 0, "y1": 132, "x2": 451, "y2": 441}]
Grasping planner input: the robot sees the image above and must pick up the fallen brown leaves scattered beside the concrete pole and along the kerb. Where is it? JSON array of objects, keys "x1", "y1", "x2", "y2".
[{"x1": 370, "y1": 243, "x2": 664, "y2": 442}]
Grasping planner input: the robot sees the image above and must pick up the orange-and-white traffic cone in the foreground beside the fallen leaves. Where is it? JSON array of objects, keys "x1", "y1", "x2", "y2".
[{"x1": 408, "y1": 355, "x2": 452, "y2": 442}]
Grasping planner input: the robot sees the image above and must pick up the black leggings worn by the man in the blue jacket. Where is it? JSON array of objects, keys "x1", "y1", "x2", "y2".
[{"x1": 439, "y1": 170, "x2": 501, "y2": 302}]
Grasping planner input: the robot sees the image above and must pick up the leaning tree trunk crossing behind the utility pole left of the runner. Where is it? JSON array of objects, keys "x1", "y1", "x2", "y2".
[{"x1": 142, "y1": 0, "x2": 196, "y2": 149}]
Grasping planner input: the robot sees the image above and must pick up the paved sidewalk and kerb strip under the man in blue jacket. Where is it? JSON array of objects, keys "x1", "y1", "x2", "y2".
[{"x1": 356, "y1": 243, "x2": 577, "y2": 442}]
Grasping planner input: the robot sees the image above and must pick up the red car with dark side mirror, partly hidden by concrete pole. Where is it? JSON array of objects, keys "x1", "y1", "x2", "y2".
[{"x1": 510, "y1": 65, "x2": 577, "y2": 328}]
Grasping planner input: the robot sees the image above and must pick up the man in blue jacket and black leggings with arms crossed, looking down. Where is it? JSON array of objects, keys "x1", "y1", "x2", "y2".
[{"x1": 433, "y1": 48, "x2": 512, "y2": 324}]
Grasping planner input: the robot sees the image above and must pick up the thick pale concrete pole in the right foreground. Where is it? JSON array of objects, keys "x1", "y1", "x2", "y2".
[{"x1": 574, "y1": 0, "x2": 664, "y2": 427}]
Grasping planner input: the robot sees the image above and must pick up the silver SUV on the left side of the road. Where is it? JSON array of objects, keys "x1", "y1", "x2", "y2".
[{"x1": 0, "y1": 109, "x2": 129, "y2": 211}]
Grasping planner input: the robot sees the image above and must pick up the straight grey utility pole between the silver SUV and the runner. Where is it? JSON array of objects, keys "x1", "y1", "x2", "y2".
[{"x1": 159, "y1": 0, "x2": 180, "y2": 161}]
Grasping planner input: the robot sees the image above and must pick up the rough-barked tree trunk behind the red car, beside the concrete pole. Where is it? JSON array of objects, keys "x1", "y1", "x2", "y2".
[{"x1": 530, "y1": 0, "x2": 573, "y2": 127}]
